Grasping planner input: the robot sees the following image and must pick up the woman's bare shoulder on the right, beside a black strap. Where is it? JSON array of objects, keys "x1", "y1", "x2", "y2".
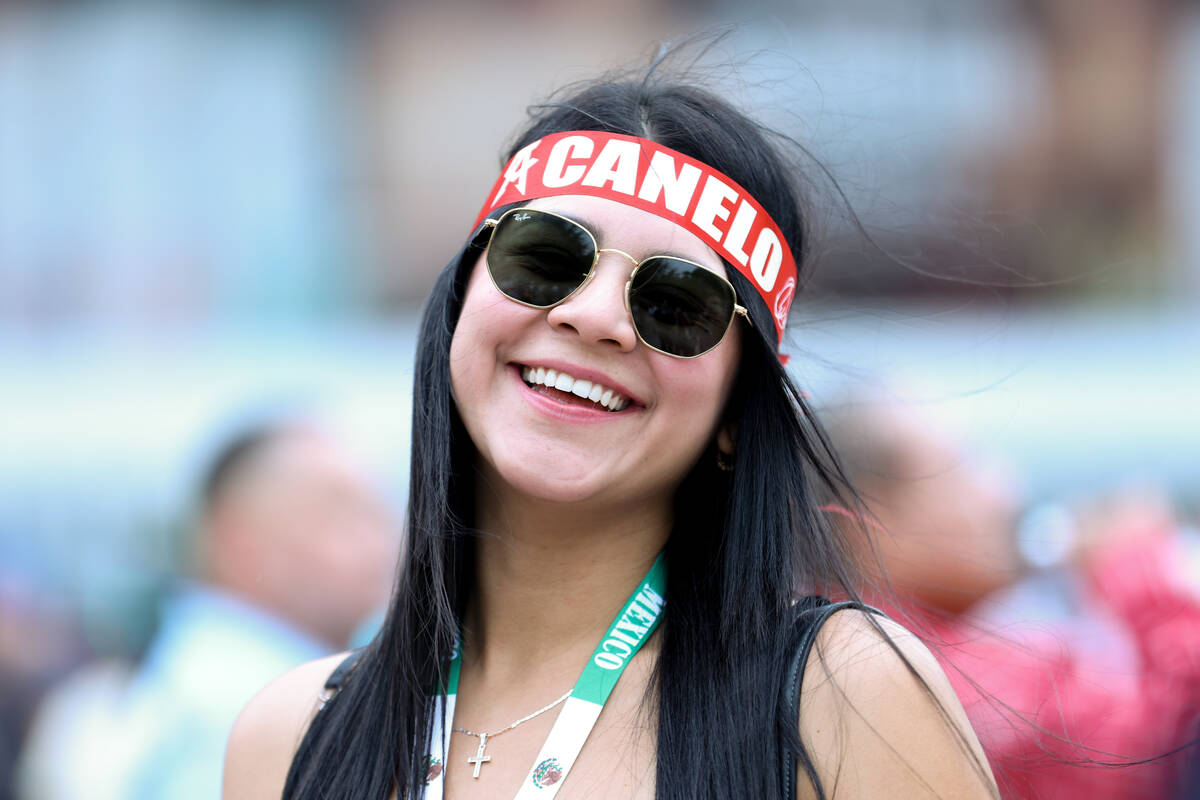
[{"x1": 797, "y1": 609, "x2": 998, "y2": 800}]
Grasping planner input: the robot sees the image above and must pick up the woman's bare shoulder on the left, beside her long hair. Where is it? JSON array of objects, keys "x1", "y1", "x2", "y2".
[{"x1": 221, "y1": 652, "x2": 347, "y2": 800}]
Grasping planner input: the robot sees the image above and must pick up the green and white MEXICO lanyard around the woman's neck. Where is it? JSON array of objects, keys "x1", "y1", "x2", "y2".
[{"x1": 425, "y1": 553, "x2": 667, "y2": 800}]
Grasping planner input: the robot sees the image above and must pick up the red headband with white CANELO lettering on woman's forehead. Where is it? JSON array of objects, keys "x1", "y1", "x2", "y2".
[{"x1": 474, "y1": 131, "x2": 796, "y2": 343}]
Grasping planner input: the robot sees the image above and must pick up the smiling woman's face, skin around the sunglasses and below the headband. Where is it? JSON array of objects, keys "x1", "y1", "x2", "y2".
[{"x1": 450, "y1": 196, "x2": 740, "y2": 504}]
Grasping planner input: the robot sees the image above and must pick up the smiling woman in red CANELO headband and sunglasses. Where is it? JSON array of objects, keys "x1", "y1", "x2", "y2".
[{"x1": 226, "y1": 70, "x2": 995, "y2": 800}]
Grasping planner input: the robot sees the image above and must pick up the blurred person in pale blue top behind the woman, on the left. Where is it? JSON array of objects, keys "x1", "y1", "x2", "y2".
[{"x1": 14, "y1": 421, "x2": 397, "y2": 800}]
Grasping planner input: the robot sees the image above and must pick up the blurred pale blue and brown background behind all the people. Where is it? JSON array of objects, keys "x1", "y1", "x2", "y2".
[{"x1": 0, "y1": 0, "x2": 1200, "y2": 798}]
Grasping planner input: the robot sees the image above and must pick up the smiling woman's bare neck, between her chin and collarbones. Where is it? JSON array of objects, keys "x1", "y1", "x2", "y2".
[{"x1": 463, "y1": 489, "x2": 671, "y2": 680}]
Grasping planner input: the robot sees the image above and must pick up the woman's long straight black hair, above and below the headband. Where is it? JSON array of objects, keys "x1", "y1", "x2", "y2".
[{"x1": 283, "y1": 70, "x2": 892, "y2": 800}]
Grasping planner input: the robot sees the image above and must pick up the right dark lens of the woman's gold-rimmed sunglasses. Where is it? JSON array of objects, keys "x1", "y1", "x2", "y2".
[{"x1": 629, "y1": 255, "x2": 736, "y2": 357}]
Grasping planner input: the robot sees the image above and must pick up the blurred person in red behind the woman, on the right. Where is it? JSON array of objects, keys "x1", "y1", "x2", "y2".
[{"x1": 823, "y1": 395, "x2": 1200, "y2": 800}]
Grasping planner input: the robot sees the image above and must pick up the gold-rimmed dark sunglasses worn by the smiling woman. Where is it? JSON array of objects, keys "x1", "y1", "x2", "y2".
[{"x1": 484, "y1": 209, "x2": 750, "y2": 359}]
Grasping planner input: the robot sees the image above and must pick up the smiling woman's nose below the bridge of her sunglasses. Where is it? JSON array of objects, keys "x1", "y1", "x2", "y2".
[{"x1": 546, "y1": 248, "x2": 637, "y2": 353}]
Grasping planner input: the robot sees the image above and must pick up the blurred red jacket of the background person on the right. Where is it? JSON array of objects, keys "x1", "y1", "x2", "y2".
[{"x1": 900, "y1": 533, "x2": 1200, "y2": 800}]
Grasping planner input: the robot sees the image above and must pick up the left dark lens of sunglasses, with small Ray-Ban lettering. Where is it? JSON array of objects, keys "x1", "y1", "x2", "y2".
[{"x1": 487, "y1": 209, "x2": 595, "y2": 307}]
